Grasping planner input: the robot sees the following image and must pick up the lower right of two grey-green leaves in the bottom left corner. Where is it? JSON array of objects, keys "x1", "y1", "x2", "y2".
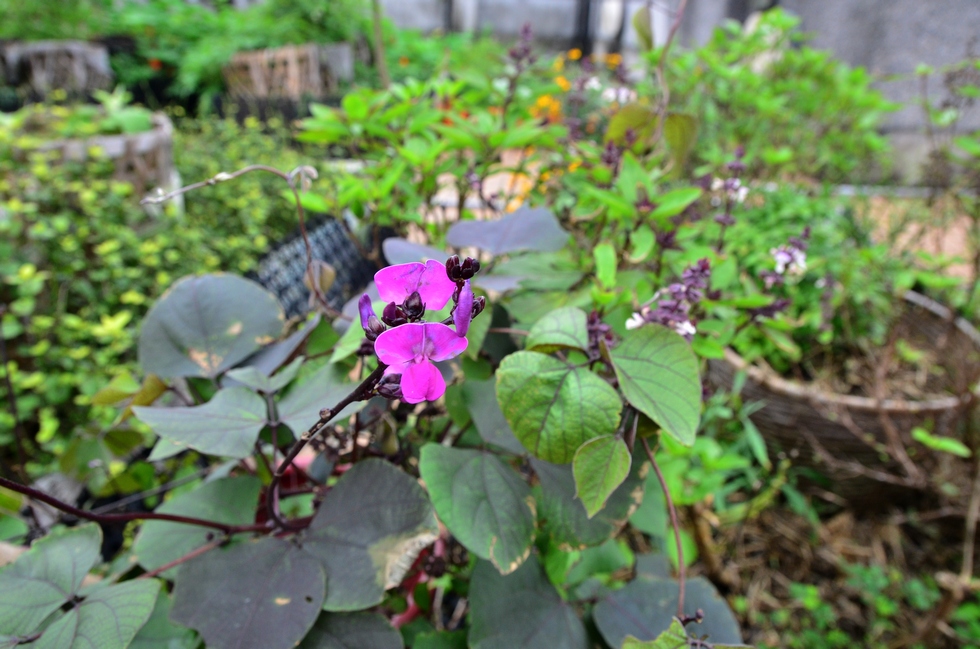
[{"x1": 31, "y1": 579, "x2": 160, "y2": 649}]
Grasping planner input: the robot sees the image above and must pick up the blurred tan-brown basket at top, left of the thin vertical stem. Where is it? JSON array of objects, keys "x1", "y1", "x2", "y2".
[{"x1": 223, "y1": 43, "x2": 354, "y2": 101}]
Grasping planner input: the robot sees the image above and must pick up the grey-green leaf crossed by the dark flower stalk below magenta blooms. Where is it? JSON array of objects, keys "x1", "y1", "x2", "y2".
[{"x1": 276, "y1": 364, "x2": 366, "y2": 435}]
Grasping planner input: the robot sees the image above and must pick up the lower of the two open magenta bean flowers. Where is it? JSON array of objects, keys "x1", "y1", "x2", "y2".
[{"x1": 374, "y1": 322, "x2": 467, "y2": 403}]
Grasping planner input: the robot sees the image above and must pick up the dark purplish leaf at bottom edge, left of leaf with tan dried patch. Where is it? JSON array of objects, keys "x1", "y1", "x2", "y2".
[{"x1": 170, "y1": 537, "x2": 326, "y2": 649}]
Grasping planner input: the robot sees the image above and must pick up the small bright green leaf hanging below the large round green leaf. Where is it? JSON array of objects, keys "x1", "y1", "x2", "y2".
[{"x1": 572, "y1": 436, "x2": 631, "y2": 518}]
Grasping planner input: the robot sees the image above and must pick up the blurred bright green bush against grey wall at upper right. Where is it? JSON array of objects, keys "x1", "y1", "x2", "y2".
[{"x1": 649, "y1": 9, "x2": 897, "y2": 182}]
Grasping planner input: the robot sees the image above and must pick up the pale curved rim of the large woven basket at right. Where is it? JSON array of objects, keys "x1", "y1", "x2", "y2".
[{"x1": 724, "y1": 291, "x2": 980, "y2": 415}]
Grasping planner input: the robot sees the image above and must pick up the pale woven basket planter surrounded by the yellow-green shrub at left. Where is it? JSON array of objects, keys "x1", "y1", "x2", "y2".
[{"x1": 25, "y1": 113, "x2": 175, "y2": 198}]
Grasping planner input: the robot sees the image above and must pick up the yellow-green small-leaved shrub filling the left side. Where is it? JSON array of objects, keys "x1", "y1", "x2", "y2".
[{"x1": 0, "y1": 115, "x2": 310, "y2": 456}]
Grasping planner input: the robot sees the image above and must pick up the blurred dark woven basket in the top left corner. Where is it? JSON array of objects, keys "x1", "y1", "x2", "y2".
[{"x1": 0, "y1": 41, "x2": 112, "y2": 97}]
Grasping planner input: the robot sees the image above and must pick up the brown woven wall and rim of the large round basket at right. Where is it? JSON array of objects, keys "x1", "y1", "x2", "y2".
[{"x1": 708, "y1": 291, "x2": 980, "y2": 503}]
